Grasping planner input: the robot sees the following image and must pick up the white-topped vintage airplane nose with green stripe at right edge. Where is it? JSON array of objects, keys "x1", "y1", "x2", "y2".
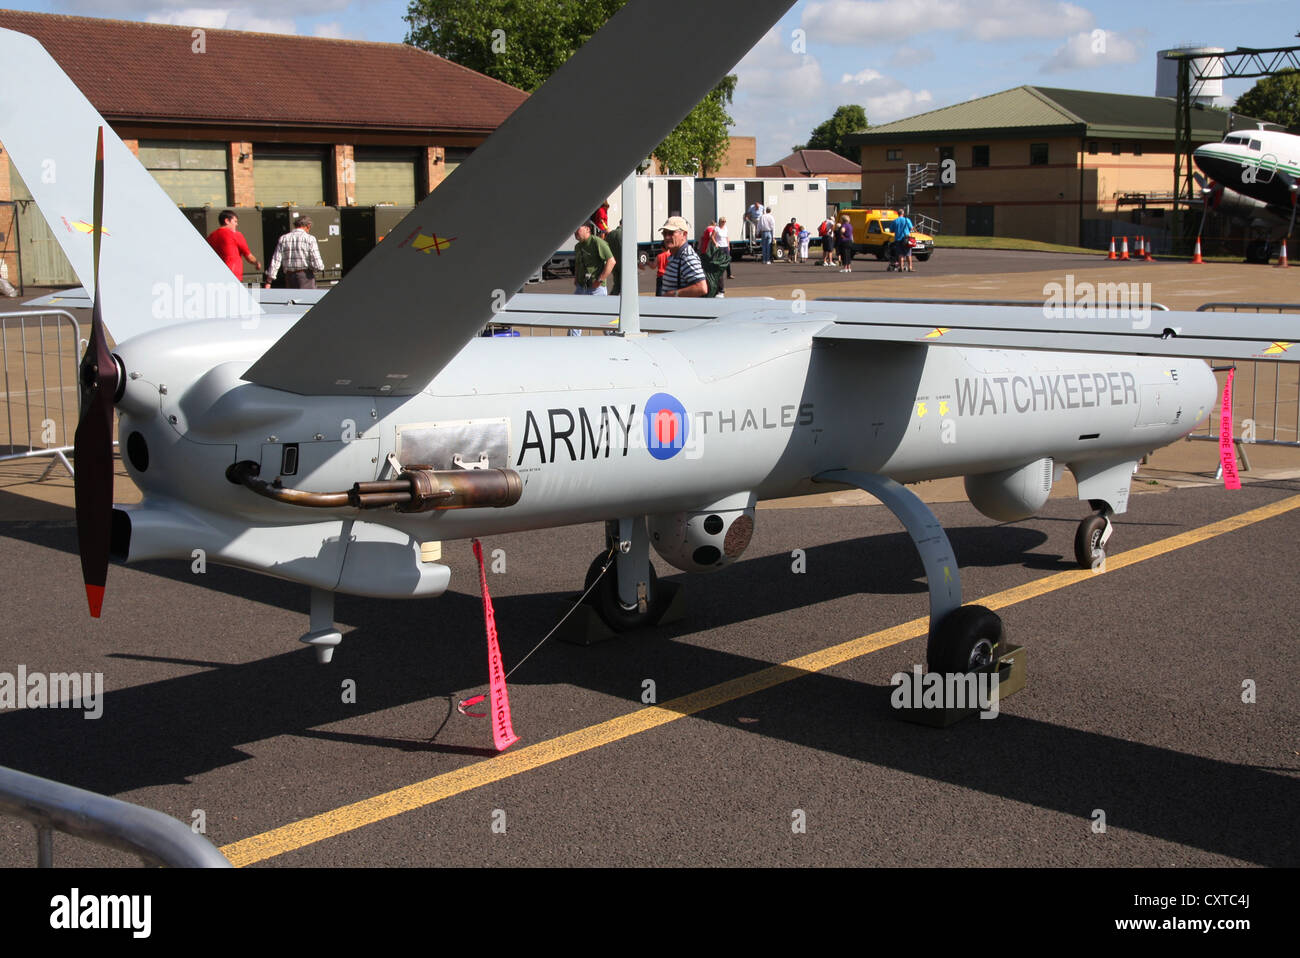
[{"x1": 1192, "y1": 130, "x2": 1300, "y2": 263}]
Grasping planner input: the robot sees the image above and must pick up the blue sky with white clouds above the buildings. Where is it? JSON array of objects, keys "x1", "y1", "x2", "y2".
[{"x1": 12, "y1": 0, "x2": 1300, "y2": 162}]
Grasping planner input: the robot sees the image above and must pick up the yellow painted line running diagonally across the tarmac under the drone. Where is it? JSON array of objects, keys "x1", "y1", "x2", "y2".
[{"x1": 221, "y1": 495, "x2": 1300, "y2": 866}]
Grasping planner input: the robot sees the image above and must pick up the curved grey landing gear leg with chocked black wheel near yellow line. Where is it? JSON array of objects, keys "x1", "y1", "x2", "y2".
[{"x1": 813, "y1": 469, "x2": 1004, "y2": 672}]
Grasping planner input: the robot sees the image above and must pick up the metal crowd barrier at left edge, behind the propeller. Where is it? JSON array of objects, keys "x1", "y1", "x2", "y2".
[{"x1": 0, "y1": 309, "x2": 83, "y2": 482}]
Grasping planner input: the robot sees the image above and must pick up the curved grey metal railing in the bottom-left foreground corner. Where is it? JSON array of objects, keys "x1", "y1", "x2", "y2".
[{"x1": 0, "y1": 768, "x2": 233, "y2": 868}]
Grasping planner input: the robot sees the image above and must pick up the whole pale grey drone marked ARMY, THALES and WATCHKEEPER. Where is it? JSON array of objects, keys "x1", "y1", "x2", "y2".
[{"x1": 0, "y1": 0, "x2": 1300, "y2": 671}]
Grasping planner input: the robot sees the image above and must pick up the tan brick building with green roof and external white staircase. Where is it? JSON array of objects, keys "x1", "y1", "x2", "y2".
[{"x1": 852, "y1": 86, "x2": 1255, "y2": 247}]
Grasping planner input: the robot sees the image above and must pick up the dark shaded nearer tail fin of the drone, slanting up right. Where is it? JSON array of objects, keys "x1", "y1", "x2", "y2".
[{"x1": 244, "y1": 0, "x2": 793, "y2": 395}]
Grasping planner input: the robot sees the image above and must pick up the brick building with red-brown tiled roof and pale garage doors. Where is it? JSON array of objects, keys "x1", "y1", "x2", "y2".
[{"x1": 0, "y1": 10, "x2": 527, "y2": 283}]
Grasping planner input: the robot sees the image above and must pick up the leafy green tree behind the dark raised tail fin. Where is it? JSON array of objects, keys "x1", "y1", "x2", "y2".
[{"x1": 406, "y1": 0, "x2": 736, "y2": 174}]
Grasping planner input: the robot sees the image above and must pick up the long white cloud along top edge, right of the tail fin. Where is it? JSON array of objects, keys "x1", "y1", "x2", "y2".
[{"x1": 802, "y1": 0, "x2": 1092, "y2": 45}]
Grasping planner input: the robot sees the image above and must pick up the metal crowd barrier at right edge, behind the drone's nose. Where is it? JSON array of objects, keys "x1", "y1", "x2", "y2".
[{"x1": 1187, "y1": 303, "x2": 1300, "y2": 471}]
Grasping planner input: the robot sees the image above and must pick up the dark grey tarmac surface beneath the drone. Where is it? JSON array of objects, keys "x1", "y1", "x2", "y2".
[{"x1": 0, "y1": 250, "x2": 1300, "y2": 867}]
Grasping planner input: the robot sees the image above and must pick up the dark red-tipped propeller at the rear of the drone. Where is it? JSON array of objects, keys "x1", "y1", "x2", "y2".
[{"x1": 73, "y1": 126, "x2": 120, "y2": 619}]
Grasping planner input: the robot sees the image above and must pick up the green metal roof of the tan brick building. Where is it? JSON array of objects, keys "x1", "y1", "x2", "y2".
[{"x1": 852, "y1": 86, "x2": 1253, "y2": 144}]
